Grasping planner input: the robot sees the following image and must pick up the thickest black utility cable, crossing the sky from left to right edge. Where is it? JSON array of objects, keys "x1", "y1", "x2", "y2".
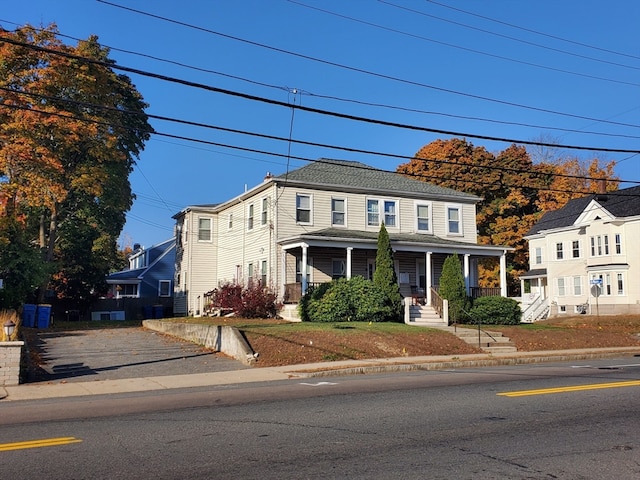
[{"x1": 0, "y1": 38, "x2": 640, "y2": 153}]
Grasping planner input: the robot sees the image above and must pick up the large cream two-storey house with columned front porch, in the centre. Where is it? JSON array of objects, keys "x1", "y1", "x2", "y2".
[{"x1": 173, "y1": 159, "x2": 510, "y2": 315}]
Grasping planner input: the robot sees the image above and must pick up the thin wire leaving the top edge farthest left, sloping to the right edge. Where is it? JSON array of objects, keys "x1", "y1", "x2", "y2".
[{"x1": 97, "y1": 0, "x2": 639, "y2": 129}]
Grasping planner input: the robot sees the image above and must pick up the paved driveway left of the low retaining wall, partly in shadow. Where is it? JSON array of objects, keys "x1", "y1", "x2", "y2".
[{"x1": 28, "y1": 327, "x2": 249, "y2": 382}]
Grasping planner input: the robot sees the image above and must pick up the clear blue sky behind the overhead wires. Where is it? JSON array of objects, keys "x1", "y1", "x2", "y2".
[{"x1": 0, "y1": 0, "x2": 640, "y2": 246}]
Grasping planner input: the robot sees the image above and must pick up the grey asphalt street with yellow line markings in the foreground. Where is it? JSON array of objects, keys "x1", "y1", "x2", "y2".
[{"x1": 0, "y1": 358, "x2": 640, "y2": 480}]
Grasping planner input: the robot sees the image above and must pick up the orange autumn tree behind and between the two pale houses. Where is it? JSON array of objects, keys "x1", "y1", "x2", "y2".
[{"x1": 397, "y1": 138, "x2": 617, "y2": 292}]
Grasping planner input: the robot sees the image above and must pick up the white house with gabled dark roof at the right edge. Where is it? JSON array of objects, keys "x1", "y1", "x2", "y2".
[{"x1": 521, "y1": 187, "x2": 640, "y2": 321}]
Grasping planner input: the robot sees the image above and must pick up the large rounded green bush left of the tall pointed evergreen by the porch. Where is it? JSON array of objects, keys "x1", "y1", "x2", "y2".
[{"x1": 300, "y1": 277, "x2": 395, "y2": 322}]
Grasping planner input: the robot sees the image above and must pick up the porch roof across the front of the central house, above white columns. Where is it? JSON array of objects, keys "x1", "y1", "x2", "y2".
[{"x1": 279, "y1": 228, "x2": 513, "y2": 256}]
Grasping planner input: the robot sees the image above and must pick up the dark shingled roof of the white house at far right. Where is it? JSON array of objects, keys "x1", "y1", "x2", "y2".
[{"x1": 527, "y1": 186, "x2": 640, "y2": 235}]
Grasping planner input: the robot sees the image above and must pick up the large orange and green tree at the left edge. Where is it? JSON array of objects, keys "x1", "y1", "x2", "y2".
[{"x1": 0, "y1": 25, "x2": 152, "y2": 308}]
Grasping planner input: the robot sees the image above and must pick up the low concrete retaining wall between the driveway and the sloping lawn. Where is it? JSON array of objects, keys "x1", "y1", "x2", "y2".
[{"x1": 142, "y1": 320, "x2": 256, "y2": 365}]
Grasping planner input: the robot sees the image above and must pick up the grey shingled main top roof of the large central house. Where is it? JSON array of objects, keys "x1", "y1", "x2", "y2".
[{"x1": 275, "y1": 158, "x2": 480, "y2": 201}]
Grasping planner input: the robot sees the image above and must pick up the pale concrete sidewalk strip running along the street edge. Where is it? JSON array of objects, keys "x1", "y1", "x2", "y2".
[{"x1": 5, "y1": 347, "x2": 640, "y2": 402}]
